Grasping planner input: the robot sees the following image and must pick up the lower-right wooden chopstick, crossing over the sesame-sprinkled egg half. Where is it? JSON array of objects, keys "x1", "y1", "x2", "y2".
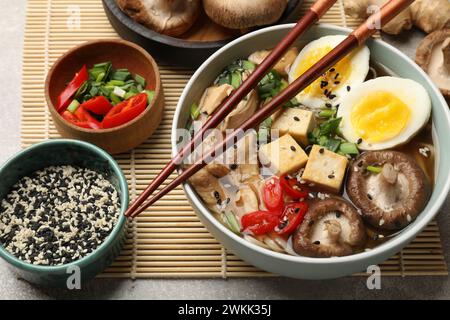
[{"x1": 129, "y1": 0, "x2": 414, "y2": 217}]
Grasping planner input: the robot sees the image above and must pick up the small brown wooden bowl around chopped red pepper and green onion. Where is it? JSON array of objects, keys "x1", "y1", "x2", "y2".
[{"x1": 45, "y1": 40, "x2": 164, "y2": 154}]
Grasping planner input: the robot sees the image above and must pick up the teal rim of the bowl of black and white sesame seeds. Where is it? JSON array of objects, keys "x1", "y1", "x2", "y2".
[{"x1": 0, "y1": 139, "x2": 129, "y2": 274}]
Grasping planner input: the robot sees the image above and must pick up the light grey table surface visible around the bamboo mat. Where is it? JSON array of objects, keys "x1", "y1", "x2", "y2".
[{"x1": 0, "y1": 0, "x2": 450, "y2": 299}]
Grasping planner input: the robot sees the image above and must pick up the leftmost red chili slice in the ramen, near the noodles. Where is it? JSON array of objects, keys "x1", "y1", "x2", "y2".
[{"x1": 241, "y1": 211, "x2": 278, "y2": 236}]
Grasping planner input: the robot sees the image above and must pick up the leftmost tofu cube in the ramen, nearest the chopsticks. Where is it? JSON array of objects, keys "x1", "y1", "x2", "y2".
[{"x1": 259, "y1": 134, "x2": 308, "y2": 175}]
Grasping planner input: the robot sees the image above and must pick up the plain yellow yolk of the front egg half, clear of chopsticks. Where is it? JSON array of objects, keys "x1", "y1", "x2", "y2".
[{"x1": 350, "y1": 91, "x2": 411, "y2": 143}]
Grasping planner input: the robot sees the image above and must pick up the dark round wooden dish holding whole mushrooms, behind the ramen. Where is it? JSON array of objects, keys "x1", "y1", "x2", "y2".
[{"x1": 103, "y1": 0, "x2": 302, "y2": 68}]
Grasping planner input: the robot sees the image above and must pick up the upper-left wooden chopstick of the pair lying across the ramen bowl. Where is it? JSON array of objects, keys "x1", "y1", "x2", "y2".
[{"x1": 125, "y1": 0, "x2": 337, "y2": 216}]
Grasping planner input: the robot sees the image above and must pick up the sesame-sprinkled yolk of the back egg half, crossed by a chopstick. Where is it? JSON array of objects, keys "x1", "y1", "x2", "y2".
[{"x1": 294, "y1": 46, "x2": 353, "y2": 96}]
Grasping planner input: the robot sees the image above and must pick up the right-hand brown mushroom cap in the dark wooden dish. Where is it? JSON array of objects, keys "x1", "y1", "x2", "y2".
[{"x1": 203, "y1": 0, "x2": 287, "y2": 29}]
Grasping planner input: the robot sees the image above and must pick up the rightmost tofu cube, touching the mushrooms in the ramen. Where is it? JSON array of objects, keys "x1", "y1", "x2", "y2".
[{"x1": 302, "y1": 145, "x2": 348, "y2": 193}]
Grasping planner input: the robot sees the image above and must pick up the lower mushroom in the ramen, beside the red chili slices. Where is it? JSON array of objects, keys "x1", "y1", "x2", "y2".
[{"x1": 293, "y1": 197, "x2": 366, "y2": 258}]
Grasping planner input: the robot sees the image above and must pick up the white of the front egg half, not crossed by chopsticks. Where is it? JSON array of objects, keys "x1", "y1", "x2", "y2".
[{"x1": 337, "y1": 77, "x2": 431, "y2": 150}]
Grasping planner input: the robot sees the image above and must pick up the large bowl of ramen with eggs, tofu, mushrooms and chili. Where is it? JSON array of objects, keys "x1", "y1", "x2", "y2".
[{"x1": 172, "y1": 24, "x2": 450, "y2": 279}]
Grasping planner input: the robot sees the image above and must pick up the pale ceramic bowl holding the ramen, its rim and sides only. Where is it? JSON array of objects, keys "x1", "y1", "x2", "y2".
[{"x1": 172, "y1": 24, "x2": 450, "y2": 279}]
